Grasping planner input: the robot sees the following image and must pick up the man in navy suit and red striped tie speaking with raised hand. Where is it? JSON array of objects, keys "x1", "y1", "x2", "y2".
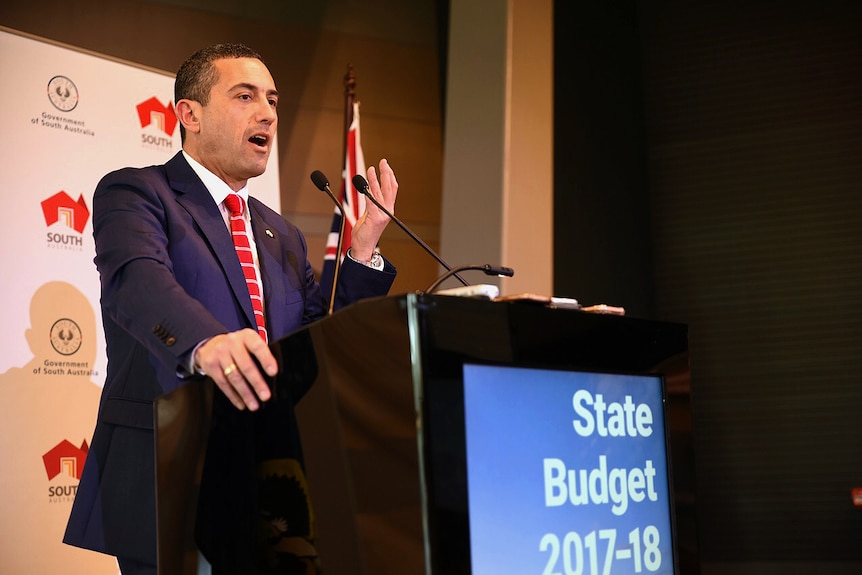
[{"x1": 64, "y1": 44, "x2": 398, "y2": 575}]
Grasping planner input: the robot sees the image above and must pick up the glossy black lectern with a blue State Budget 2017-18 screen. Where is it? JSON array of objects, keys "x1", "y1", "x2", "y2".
[{"x1": 156, "y1": 294, "x2": 688, "y2": 575}]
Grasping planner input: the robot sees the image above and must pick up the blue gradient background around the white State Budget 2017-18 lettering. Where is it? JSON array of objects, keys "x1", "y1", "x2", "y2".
[{"x1": 464, "y1": 365, "x2": 673, "y2": 575}]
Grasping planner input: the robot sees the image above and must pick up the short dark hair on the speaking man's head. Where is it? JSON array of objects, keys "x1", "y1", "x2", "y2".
[{"x1": 174, "y1": 44, "x2": 263, "y2": 141}]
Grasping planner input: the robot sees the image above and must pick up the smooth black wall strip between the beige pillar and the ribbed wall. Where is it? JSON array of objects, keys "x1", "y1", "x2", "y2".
[{"x1": 554, "y1": 0, "x2": 653, "y2": 318}]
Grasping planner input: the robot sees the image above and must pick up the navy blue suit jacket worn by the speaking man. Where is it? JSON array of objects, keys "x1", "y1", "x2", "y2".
[{"x1": 64, "y1": 153, "x2": 395, "y2": 563}]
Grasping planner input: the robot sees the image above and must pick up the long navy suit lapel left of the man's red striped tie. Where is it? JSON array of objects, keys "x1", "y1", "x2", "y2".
[{"x1": 165, "y1": 153, "x2": 257, "y2": 327}]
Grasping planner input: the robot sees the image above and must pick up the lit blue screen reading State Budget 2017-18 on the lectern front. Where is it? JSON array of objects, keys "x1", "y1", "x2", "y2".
[{"x1": 425, "y1": 363, "x2": 676, "y2": 575}]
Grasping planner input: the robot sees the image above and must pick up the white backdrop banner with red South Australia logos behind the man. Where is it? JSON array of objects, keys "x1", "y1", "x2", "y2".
[{"x1": 0, "y1": 27, "x2": 280, "y2": 575}]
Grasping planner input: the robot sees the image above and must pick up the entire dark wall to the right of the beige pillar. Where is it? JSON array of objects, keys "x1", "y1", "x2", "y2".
[{"x1": 555, "y1": 0, "x2": 862, "y2": 573}]
